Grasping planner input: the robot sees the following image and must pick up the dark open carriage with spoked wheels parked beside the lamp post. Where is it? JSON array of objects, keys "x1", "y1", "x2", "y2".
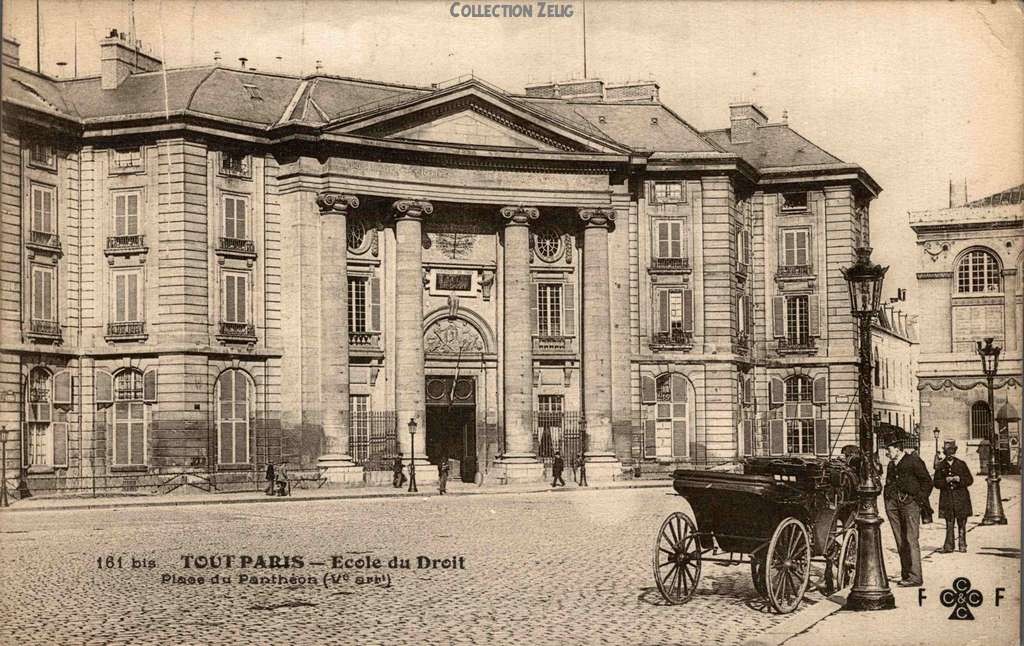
[{"x1": 653, "y1": 458, "x2": 859, "y2": 612}]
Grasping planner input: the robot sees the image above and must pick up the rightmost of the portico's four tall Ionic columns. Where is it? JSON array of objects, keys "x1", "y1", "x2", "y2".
[{"x1": 580, "y1": 208, "x2": 622, "y2": 482}]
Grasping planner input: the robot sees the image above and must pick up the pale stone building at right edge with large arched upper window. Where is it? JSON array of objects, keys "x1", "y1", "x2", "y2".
[{"x1": 910, "y1": 185, "x2": 1024, "y2": 472}]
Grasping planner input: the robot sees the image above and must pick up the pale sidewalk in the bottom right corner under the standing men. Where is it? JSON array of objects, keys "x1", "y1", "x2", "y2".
[{"x1": 748, "y1": 476, "x2": 1021, "y2": 646}]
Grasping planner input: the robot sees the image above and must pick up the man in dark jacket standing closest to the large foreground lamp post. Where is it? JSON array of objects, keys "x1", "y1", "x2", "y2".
[{"x1": 884, "y1": 439, "x2": 932, "y2": 588}]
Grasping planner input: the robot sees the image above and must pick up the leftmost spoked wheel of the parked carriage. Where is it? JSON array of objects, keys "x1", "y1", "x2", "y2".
[{"x1": 654, "y1": 512, "x2": 700, "y2": 605}]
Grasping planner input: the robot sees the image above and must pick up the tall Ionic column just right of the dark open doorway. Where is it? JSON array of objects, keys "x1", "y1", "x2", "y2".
[{"x1": 496, "y1": 207, "x2": 544, "y2": 484}]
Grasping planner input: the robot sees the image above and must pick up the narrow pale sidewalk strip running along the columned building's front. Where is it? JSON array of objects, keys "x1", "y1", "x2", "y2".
[{"x1": 0, "y1": 479, "x2": 673, "y2": 515}]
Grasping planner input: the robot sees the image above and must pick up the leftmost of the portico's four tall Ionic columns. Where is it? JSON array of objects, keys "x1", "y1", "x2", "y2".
[{"x1": 316, "y1": 191, "x2": 362, "y2": 485}]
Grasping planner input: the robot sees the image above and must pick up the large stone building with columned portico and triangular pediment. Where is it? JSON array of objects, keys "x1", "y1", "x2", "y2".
[{"x1": 0, "y1": 33, "x2": 880, "y2": 489}]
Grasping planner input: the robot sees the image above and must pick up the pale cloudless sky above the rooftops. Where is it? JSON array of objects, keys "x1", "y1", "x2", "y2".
[{"x1": 3, "y1": 0, "x2": 1024, "y2": 312}]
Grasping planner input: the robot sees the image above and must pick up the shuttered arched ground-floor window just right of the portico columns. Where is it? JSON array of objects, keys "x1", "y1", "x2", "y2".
[{"x1": 644, "y1": 374, "x2": 693, "y2": 458}]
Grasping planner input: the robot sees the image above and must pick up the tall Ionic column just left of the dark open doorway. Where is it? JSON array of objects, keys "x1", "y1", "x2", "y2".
[{"x1": 393, "y1": 200, "x2": 437, "y2": 485}]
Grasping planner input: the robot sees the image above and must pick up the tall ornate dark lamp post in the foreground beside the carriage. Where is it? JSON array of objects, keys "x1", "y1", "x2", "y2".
[{"x1": 842, "y1": 248, "x2": 896, "y2": 610}]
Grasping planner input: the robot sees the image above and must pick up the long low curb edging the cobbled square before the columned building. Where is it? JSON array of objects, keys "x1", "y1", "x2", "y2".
[{"x1": 0, "y1": 480, "x2": 675, "y2": 516}]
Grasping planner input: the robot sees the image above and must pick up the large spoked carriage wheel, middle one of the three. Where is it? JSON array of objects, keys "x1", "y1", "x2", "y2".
[{"x1": 764, "y1": 516, "x2": 811, "y2": 613}]
